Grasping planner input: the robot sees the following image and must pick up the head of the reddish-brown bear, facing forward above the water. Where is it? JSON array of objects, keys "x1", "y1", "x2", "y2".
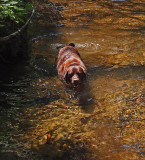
[{"x1": 65, "y1": 65, "x2": 86, "y2": 87}]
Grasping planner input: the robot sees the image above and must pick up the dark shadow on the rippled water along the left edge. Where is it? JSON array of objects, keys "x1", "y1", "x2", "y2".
[{"x1": 0, "y1": 55, "x2": 59, "y2": 160}]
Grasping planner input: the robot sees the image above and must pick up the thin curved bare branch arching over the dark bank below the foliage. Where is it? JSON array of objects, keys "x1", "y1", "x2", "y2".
[{"x1": 0, "y1": 9, "x2": 35, "y2": 42}]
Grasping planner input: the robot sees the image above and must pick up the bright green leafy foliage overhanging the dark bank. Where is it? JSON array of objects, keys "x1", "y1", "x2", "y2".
[{"x1": 0, "y1": 0, "x2": 32, "y2": 27}]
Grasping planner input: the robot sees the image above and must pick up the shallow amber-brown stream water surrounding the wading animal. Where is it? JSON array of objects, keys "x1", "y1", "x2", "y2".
[{"x1": 0, "y1": 0, "x2": 145, "y2": 160}]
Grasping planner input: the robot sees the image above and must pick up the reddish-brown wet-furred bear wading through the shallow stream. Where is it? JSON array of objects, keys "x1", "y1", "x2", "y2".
[{"x1": 57, "y1": 43, "x2": 87, "y2": 87}]
